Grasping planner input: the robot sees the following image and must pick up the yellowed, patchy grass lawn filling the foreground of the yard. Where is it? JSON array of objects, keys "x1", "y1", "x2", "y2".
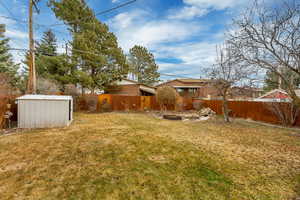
[{"x1": 0, "y1": 113, "x2": 300, "y2": 200}]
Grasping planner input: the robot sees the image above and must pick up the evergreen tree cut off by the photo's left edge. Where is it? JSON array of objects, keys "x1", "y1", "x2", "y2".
[{"x1": 0, "y1": 25, "x2": 20, "y2": 87}]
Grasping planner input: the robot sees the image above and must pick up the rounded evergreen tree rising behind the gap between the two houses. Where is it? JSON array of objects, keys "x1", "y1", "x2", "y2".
[{"x1": 128, "y1": 45, "x2": 160, "y2": 85}]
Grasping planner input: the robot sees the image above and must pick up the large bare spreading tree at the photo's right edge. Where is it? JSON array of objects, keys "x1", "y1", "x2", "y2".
[{"x1": 229, "y1": 0, "x2": 300, "y2": 106}]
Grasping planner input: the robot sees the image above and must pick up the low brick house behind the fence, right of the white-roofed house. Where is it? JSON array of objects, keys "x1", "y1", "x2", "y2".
[{"x1": 157, "y1": 79, "x2": 218, "y2": 98}]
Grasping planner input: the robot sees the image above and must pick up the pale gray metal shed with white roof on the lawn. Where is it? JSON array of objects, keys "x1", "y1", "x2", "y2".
[{"x1": 17, "y1": 95, "x2": 73, "y2": 128}]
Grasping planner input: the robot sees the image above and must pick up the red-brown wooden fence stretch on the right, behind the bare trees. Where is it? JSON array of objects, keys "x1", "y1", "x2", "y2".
[{"x1": 202, "y1": 100, "x2": 300, "y2": 126}]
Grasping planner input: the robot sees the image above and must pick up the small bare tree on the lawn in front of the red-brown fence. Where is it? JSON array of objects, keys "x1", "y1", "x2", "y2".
[{"x1": 208, "y1": 42, "x2": 256, "y2": 122}]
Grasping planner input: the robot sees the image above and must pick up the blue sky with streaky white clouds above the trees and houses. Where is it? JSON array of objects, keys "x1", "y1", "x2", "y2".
[{"x1": 0, "y1": 0, "x2": 255, "y2": 79}]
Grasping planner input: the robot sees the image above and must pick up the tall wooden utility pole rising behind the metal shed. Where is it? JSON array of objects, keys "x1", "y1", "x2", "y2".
[{"x1": 27, "y1": 0, "x2": 38, "y2": 94}]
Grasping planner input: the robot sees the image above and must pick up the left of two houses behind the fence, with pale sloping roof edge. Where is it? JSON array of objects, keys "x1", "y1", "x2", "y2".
[{"x1": 105, "y1": 79, "x2": 156, "y2": 96}]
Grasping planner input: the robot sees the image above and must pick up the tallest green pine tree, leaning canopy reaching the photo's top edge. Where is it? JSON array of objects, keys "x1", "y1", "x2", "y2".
[{"x1": 50, "y1": 0, "x2": 128, "y2": 91}]
